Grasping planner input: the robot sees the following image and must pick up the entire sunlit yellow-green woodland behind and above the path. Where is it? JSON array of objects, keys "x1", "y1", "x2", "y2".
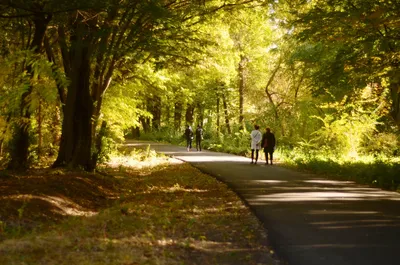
[{"x1": 0, "y1": 0, "x2": 400, "y2": 189}]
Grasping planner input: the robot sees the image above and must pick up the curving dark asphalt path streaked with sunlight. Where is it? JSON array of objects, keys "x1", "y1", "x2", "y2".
[{"x1": 127, "y1": 141, "x2": 400, "y2": 265}]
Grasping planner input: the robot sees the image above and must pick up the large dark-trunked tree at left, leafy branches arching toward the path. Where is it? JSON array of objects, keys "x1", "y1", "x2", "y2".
[{"x1": 50, "y1": 1, "x2": 211, "y2": 170}]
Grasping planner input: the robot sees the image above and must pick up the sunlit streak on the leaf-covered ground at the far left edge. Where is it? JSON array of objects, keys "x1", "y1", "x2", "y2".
[{"x1": 1, "y1": 194, "x2": 97, "y2": 216}]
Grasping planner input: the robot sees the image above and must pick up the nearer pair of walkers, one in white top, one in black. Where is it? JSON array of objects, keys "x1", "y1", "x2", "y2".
[{"x1": 250, "y1": 125, "x2": 275, "y2": 165}]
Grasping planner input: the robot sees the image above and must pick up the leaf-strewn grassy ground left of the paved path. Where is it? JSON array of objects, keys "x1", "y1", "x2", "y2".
[{"x1": 0, "y1": 152, "x2": 279, "y2": 265}]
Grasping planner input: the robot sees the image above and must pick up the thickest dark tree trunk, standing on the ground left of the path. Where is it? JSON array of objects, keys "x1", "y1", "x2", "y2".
[{"x1": 53, "y1": 21, "x2": 95, "y2": 171}]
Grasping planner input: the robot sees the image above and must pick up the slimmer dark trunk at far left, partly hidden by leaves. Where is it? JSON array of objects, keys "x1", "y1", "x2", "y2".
[{"x1": 7, "y1": 13, "x2": 51, "y2": 169}]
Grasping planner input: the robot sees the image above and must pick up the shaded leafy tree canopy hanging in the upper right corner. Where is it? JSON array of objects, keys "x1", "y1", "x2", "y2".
[{"x1": 281, "y1": 0, "x2": 400, "y2": 128}]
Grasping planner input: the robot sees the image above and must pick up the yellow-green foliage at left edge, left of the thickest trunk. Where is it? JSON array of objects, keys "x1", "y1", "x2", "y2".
[{"x1": 0, "y1": 47, "x2": 68, "y2": 163}]
